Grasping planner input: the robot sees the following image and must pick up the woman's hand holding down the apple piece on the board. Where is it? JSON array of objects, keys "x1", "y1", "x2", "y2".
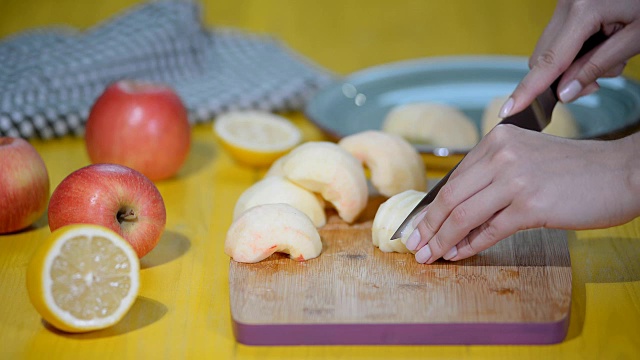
[{"x1": 407, "y1": 125, "x2": 640, "y2": 263}]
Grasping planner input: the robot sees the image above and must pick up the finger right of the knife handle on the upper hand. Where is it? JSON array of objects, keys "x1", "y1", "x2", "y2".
[{"x1": 558, "y1": 23, "x2": 640, "y2": 102}]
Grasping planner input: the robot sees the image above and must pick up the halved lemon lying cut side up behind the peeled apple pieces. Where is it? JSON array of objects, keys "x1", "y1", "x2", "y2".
[{"x1": 213, "y1": 111, "x2": 302, "y2": 166}]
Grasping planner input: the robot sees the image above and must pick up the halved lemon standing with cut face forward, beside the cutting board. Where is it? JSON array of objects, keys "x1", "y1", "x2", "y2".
[{"x1": 27, "y1": 224, "x2": 140, "y2": 332}]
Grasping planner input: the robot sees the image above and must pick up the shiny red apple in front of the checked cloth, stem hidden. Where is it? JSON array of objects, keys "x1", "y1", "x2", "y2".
[{"x1": 85, "y1": 80, "x2": 191, "y2": 181}]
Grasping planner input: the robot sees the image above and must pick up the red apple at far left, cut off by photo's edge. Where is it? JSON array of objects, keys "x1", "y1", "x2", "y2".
[{"x1": 0, "y1": 137, "x2": 49, "y2": 234}]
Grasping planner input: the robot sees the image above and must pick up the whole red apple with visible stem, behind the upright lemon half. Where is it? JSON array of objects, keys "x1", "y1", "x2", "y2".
[{"x1": 49, "y1": 164, "x2": 167, "y2": 258}]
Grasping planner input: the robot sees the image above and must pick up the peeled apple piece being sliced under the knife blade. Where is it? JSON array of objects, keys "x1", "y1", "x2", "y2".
[{"x1": 371, "y1": 190, "x2": 426, "y2": 253}]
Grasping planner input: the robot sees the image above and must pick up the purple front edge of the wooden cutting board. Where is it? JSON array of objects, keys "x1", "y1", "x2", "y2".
[{"x1": 231, "y1": 315, "x2": 569, "y2": 346}]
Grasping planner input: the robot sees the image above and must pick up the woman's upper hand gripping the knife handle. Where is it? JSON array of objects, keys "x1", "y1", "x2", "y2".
[{"x1": 500, "y1": 0, "x2": 640, "y2": 118}]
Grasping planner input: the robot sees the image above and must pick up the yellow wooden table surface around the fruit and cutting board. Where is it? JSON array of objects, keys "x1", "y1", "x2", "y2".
[{"x1": 0, "y1": 0, "x2": 640, "y2": 359}]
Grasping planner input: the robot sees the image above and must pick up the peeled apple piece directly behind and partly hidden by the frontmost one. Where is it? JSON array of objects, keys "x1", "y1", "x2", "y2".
[{"x1": 233, "y1": 176, "x2": 326, "y2": 227}]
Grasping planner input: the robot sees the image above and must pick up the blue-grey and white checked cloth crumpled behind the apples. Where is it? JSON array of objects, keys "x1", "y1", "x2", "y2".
[{"x1": 0, "y1": 1, "x2": 332, "y2": 139}]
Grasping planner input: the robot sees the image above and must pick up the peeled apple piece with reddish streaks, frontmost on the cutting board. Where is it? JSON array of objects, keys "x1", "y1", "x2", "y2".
[{"x1": 224, "y1": 204, "x2": 322, "y2": 263}]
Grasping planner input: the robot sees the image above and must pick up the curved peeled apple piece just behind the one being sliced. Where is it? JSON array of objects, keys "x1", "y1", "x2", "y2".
[{"x1": 338, "y1": 130, "x2": 427, "y2": 197}]
